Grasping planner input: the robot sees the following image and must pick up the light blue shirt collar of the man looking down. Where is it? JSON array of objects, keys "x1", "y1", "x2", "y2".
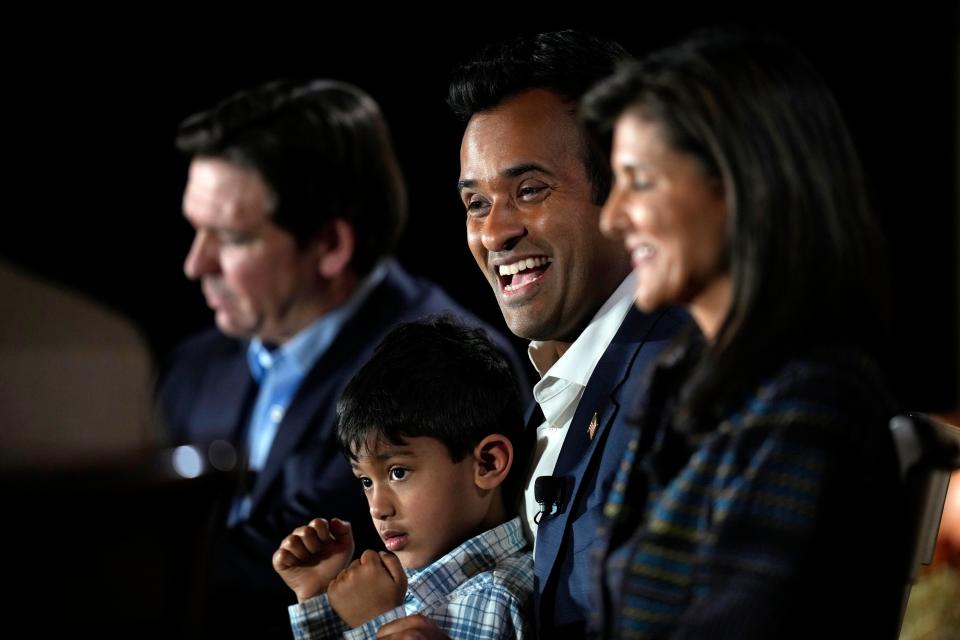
[{"x1": 247, "y1": 259, "x2": 392, "y2": 382}]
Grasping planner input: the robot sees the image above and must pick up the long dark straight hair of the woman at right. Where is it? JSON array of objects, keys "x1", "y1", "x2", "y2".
[{"x1": 582, "y1": 29, "x2": 887, "y2": 422}]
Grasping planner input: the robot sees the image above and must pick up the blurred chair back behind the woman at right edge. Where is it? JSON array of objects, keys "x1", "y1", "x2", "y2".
[{"x1": 890, "y1": 413, "x2": 960, "y2": 636}]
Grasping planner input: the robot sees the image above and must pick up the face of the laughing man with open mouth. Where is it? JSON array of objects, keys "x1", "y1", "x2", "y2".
[{"x1": 459, "y1": 89, "x2": 630, "y2": 350}]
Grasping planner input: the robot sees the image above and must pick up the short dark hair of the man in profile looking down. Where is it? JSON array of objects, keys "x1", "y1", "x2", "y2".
[{"x1": 176, "y1": 80, "x2": 407, "y2": 275}]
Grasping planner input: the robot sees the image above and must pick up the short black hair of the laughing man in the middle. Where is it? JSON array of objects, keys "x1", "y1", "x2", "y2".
[{"x1": 447, "y1": 29, "x2": 630, "y2": 204}]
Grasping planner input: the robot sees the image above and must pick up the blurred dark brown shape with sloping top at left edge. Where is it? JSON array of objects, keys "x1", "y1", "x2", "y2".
[{"x1": 0, "y1": 259, "x2": 163, "y2": 468}]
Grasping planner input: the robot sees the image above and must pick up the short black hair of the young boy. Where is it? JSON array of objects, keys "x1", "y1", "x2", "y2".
[{"x1": 337, "y1": 316, "x2": 523, "y2": 462}]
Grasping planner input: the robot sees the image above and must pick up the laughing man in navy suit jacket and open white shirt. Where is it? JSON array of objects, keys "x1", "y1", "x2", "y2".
[{"x1": 448, "y1": 31, "x2": 687, "y2": 638}]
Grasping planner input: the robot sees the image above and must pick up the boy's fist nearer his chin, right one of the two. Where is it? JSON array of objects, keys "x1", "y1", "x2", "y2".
[{"x1": 327, "y1": 550, "x2": 407, "y2": 627}]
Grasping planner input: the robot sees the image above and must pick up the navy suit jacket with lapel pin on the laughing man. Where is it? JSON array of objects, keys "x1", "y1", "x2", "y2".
[{"x1": 526, "y1": 308, "x2": 689, "y2": 638}]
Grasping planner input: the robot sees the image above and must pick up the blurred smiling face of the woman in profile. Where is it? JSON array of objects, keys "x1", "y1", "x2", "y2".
[{"x1": 600, "y1": 110, "x2": 731, "y2": 338}]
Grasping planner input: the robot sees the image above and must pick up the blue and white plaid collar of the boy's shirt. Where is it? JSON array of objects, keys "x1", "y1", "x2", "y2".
[{"x1": 406, "y1": 517, "x2": 528, "y2": 601}]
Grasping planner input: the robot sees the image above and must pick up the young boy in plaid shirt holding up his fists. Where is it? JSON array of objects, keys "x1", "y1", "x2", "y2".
[{"x1": 273, "y1": 317, "x2": 533, "y2": 639}]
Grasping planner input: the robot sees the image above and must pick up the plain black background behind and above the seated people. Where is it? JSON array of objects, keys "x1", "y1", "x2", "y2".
[{"x1": 0, "y1": 2, "x2": 960, "y2": 410}]
